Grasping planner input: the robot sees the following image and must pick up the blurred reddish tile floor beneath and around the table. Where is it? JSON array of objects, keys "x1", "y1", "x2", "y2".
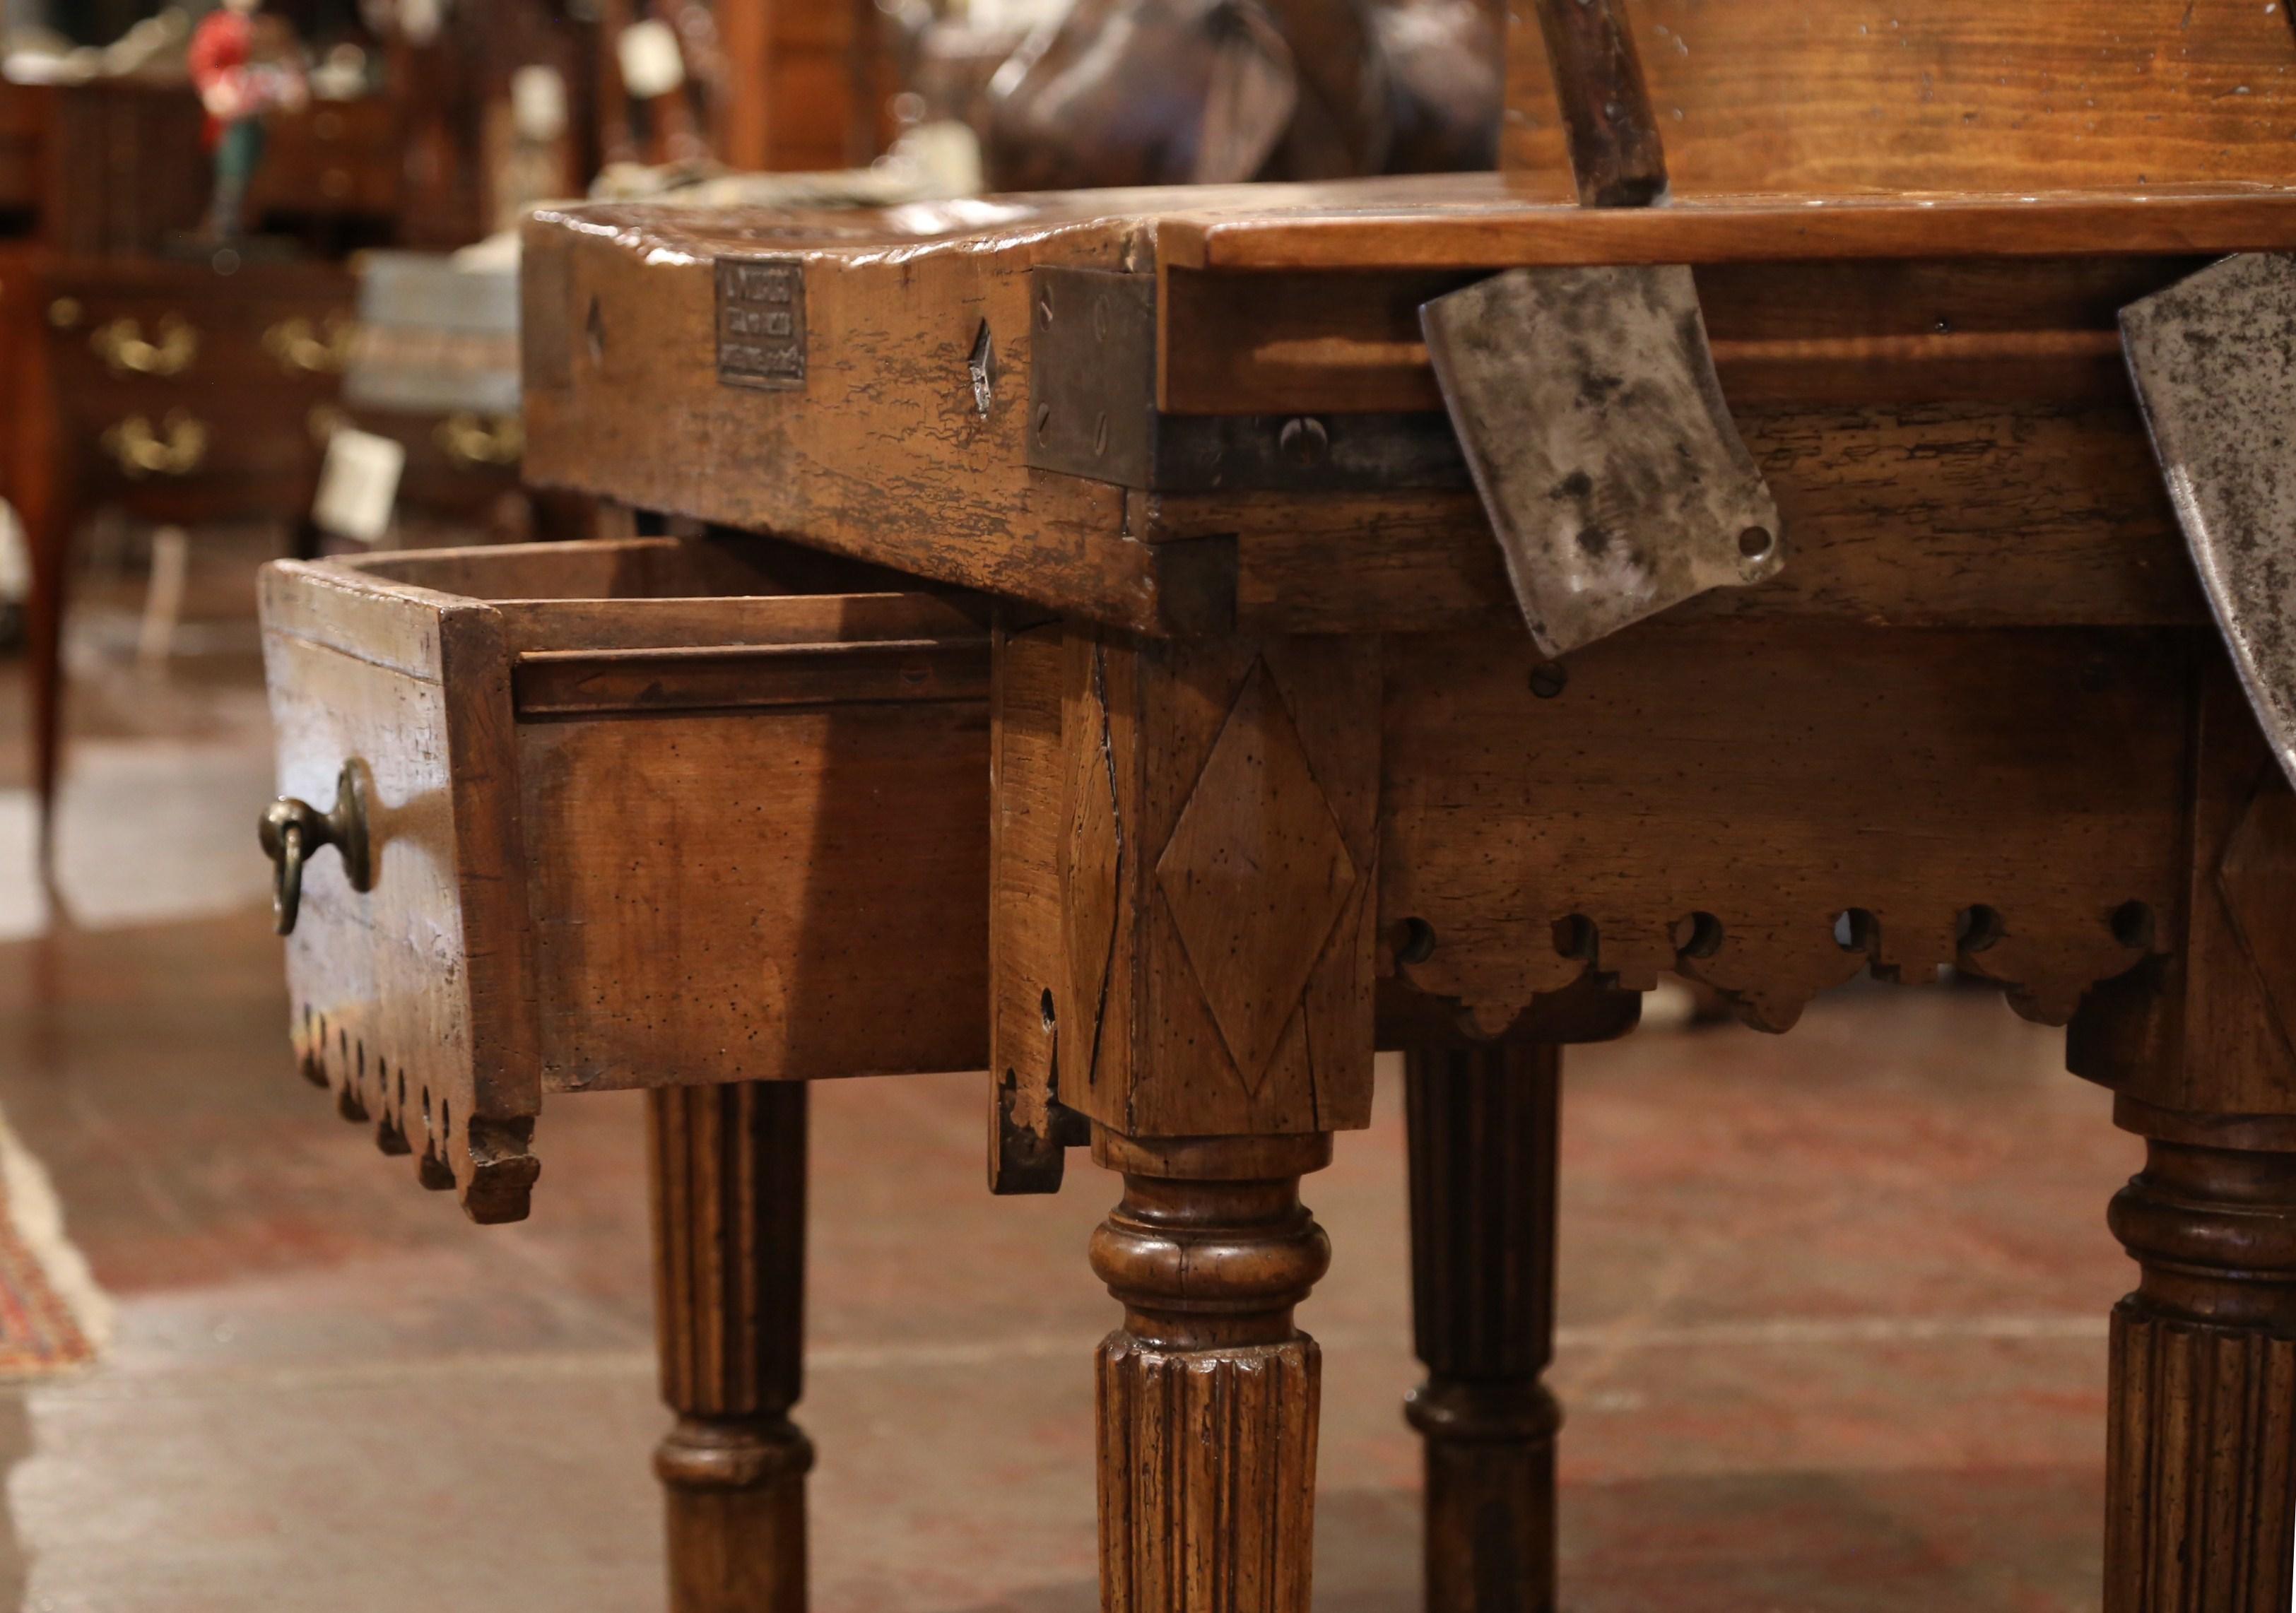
[{"x1": 0, "y1": 587, "x2": 2136, "y2": 1613}]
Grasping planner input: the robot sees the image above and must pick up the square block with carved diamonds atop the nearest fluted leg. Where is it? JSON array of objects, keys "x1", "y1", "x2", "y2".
[{"x1": 1052, "y1": 631, "x2": 1380, "y2": 1138}]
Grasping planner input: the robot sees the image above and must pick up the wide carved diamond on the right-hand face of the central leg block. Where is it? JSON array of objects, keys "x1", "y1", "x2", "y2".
[{"x1": 1155, "y1": 663, "x2": 1357, "y2": 1092}]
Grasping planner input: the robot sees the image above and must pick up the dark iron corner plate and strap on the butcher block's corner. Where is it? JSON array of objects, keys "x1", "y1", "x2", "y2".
[{"x1": 1029, "y1": 266, "x2": 1474, "y2": 493}]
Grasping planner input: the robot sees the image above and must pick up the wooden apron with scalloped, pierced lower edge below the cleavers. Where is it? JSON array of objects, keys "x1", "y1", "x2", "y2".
[{"x1": 1380, "y1": 622, "x2": 2193, "y2": 1032}]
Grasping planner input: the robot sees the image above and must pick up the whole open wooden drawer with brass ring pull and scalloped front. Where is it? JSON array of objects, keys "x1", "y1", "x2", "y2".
[{"x1": 261, "y1": 537, "x2": 989, "y2": 1221}]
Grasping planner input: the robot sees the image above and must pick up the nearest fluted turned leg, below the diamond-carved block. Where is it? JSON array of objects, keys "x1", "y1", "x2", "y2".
[{"x1": 1093, "y1": 1131, "x2": 1331, "y2": 1613}]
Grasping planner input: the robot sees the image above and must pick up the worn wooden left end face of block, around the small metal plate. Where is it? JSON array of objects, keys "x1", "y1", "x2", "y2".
[{"x1": 526, "y1": 198, "x2": 1217, "y2": 629}]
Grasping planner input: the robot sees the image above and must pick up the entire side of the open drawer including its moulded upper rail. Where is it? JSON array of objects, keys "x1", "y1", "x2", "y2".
[{"x1": 505, "y1": 587, "x2": 989, "y2": 1092}]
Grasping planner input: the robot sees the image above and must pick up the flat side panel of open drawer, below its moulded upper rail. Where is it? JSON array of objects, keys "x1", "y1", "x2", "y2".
[{"x1": 519, "y1": 693, "x2": 989, "y2": 1092}]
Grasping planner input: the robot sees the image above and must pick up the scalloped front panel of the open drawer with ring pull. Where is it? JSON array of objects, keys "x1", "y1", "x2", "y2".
[{"x1": 264, "y1": 567, "x2": 540, "y2": 1221}]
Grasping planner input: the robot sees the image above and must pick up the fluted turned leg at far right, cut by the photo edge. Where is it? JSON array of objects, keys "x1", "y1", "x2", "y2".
[{"x1": 2105, "y1": 1140, "x2": 2296, "y2": 1613}]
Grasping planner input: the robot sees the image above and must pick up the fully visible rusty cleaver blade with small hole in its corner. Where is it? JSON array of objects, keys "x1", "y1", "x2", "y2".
[{"x1": 1419, "y1": 264, "x2": 1786, "y2": 656}]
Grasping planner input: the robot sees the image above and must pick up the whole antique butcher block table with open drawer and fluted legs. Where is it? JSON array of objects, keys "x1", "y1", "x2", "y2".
[{"x1": 264, "y1": 0, "x2": 2296, "y2": 1613}]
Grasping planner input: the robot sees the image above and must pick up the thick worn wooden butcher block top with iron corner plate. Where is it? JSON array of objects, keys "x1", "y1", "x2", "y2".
[{"x1": 524, "y1": 175, "x2": 2296, "y2": 636}]
